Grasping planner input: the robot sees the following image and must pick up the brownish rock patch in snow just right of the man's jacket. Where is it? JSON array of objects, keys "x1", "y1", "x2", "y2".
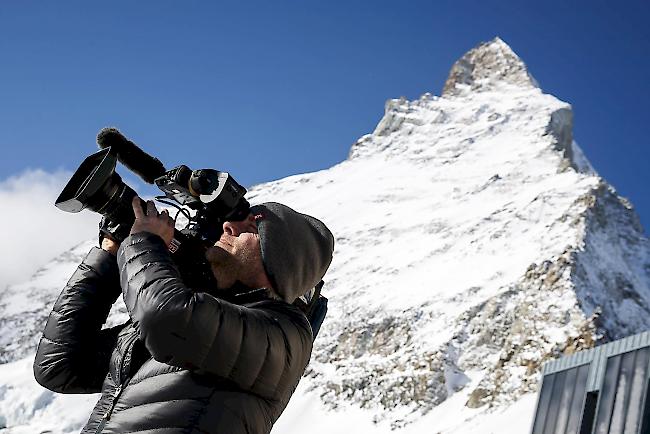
[{"x1": 306, "y1": 312, "x2": 468, "y2": 424}]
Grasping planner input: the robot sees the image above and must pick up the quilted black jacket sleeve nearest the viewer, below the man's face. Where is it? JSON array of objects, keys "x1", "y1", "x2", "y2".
[{"x1": 118, "y1": 232, "x2": 312, "y2": 400}]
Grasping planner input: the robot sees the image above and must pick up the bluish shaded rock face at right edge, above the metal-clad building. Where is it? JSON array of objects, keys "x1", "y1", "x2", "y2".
[{"x1": 573, "y1": 182, "x2": 650, "y2": 340}]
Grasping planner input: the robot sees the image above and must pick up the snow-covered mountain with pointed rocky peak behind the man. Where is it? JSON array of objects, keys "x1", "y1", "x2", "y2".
[{"x1": 0, "y1": 38, "x2": 650, "y2": 434}]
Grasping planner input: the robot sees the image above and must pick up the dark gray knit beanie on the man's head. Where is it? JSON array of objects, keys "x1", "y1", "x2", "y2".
[{"x1": 251, "y1": 202, "x2": 334, "y2": 303}]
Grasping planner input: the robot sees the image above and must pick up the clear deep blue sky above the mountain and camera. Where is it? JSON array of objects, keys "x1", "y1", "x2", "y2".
[{"x1": 0, "y1": 0, "x2": 650, "y2": 231}]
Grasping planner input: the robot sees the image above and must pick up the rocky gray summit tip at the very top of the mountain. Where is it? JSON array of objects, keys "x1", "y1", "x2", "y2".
[{"x1": 442, "y1": 37, "x2": 539, "y2": 97}]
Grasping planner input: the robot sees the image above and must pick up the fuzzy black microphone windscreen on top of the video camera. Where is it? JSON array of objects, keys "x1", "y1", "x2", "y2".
[{"x1": 97, "y1": 128, "x2": 166, "y2": 184}]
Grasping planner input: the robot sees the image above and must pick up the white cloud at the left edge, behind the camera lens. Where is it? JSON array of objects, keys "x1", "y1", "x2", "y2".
[{"x1": 0, "y1": 169, "x2": 100, "y2": 292}]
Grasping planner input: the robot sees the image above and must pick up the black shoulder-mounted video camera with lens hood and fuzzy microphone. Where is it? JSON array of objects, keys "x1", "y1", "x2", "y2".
[{"x1": 55, "y1": 128, "x2": 327, "y2": 338}]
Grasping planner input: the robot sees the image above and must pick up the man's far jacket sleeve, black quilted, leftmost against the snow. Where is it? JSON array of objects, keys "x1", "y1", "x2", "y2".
[{"x1": 34, "y1": 247, "x2": 122, "y2": 393}]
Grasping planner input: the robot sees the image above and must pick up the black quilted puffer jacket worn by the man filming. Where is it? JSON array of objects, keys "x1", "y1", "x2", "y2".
[{"x1": 34, "y1": 232, "x2": 312, "y2": 434}]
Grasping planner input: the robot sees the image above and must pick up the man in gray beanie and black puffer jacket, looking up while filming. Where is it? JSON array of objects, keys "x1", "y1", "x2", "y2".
[{"x1": 34, "y1": 197, "x2": 334, "y2": 434}]
